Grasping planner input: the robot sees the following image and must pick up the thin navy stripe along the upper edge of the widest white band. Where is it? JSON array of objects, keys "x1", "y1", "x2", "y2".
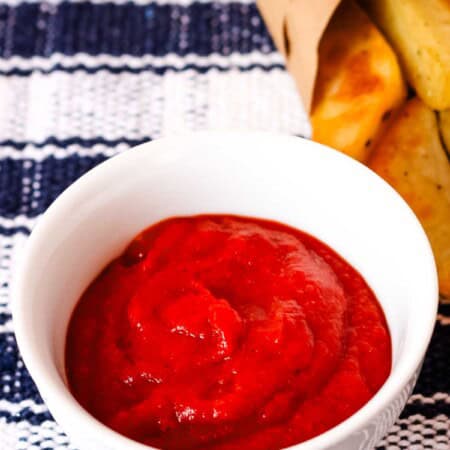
[{"x1": 0, "y1": 63, "x2": 285, "y2": 77}]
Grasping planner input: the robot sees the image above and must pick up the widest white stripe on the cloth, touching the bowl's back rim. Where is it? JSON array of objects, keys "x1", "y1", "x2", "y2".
[{"x1": 0, "y1": 68, "x2": 310, "y2": 144}]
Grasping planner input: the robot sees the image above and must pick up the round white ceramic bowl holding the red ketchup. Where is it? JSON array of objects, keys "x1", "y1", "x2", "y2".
[{"x1": 13, "y1": 132, "x2": 438, "y2": 450}]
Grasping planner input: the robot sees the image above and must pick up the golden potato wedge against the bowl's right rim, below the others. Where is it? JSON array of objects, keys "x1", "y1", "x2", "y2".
[{"x1": 368, "y1": 98, "x2": 450, "y2": 297}]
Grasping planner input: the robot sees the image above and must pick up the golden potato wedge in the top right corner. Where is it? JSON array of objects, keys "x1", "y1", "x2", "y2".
[{"x1": 362, "y1": 0, "x2": 450, "y2": 110}]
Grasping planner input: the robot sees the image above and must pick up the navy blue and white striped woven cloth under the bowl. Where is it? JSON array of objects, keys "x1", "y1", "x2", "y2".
[{"x1": 0, "y1": 0, "x2": 450, "y2": 450}]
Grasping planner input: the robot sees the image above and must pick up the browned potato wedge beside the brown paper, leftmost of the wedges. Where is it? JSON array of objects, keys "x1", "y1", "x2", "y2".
[{"x1": 311, "y1": 1, "x2": 406, "y2": 162}]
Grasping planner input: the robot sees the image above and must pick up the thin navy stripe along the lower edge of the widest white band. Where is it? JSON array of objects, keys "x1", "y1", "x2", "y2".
[{"x1": 0, "y1": 136, "x2": 151, "y2": 150}]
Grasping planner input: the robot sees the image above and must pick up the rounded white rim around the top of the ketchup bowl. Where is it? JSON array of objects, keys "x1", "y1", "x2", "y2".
[{"x1": 11, "y1": 130, "x2": 439, "y2": 450}]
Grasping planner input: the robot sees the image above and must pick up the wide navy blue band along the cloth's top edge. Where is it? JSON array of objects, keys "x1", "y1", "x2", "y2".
[{"x1": 0, "y1": 2, "x2": 274, "y2": 58}]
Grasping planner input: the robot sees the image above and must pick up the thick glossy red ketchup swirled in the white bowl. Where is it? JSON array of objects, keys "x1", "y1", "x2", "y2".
[{"x1": 66, "y1": 215, "x2": 391, "y2": 450}]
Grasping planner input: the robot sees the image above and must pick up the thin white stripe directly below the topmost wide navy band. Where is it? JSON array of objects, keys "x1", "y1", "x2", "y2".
[{"x1": 0, "y1": 51, "x2": 284, "y2": 72}]
